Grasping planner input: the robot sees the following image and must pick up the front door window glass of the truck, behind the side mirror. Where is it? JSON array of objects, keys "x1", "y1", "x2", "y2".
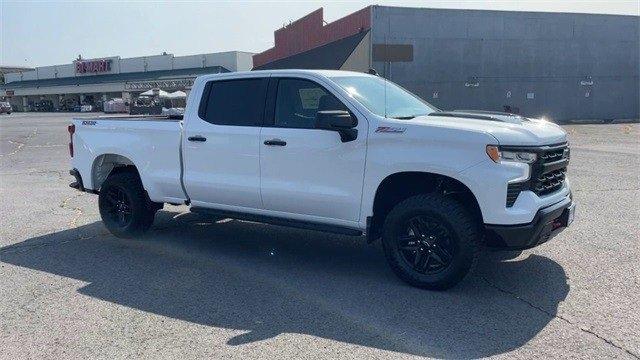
[{"x1": 275, "y1": 79, "x2": 348, "y2": 129}]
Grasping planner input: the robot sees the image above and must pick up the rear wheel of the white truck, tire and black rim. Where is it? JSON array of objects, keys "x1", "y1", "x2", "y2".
[{"x1": 98, "y1": 171, "x2": 158, "y2": 239}]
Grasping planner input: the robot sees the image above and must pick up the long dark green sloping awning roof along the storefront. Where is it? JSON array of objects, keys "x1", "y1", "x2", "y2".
[{"x1": 0, "y1": 66, "x2": 229, "y2": 90}]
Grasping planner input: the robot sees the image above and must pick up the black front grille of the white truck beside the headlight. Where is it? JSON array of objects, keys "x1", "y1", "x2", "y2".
[{"x1": 505, "y1": 143, "x2": 569, "y2": 207}]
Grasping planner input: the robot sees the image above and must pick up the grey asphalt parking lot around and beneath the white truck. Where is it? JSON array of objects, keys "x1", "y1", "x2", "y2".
[{"x1": 0, "y1": 113, "x2": 640, "y2": 359}]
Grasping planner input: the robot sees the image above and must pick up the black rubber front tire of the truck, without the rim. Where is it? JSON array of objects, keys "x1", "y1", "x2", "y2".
[{"x1": 382, "y1": 193, "x2": 480, "y2": 290}]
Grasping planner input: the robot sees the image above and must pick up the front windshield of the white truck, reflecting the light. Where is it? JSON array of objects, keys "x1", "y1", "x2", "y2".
[{"x1": 331, "y1": 76, "x2": 438, "y2": 119}]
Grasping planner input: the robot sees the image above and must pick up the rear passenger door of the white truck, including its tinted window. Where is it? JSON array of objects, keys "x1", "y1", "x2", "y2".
[{"x1": 183, "y1": 77, "x2": 269, "y2": 211}]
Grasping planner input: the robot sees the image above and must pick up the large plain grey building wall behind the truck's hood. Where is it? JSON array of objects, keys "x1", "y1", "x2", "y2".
[{"x1": 371, "y1": 6, "x2": 640, "y2": 120}]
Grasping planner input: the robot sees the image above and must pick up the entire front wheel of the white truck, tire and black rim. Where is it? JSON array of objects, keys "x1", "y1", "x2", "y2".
[{"x1": 382, "y1": 194, "x2": 479, "y2": 290}]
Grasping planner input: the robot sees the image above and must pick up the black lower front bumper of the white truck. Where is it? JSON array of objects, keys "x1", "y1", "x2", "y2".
[{"x1": 485, "y1": 196, "x2": 575, "y2": 250}]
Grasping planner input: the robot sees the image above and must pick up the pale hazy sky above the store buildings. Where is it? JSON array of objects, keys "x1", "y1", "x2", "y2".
[{"x1": 0, "y1": 0, "x2": 640, "y2": 66}]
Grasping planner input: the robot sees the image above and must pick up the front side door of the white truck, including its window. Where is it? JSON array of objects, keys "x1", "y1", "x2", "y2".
[{"x1": 260, "y1": 77, "x2": 367, "y2": 224}]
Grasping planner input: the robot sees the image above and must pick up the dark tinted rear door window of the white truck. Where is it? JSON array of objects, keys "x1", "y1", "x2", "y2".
[{"x1": 203, "y1": 79, "x2": 268, "y2": 126}]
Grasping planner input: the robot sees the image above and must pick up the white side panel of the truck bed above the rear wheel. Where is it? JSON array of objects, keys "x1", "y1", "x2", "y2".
[{"x1": 72, "y1": 115, "x2": 186, "y2": 203}]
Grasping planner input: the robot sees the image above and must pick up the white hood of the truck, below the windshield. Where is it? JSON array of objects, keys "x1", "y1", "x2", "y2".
[{"x1": 412, "y1": 110, "x2": 567, "y2": 146}]
